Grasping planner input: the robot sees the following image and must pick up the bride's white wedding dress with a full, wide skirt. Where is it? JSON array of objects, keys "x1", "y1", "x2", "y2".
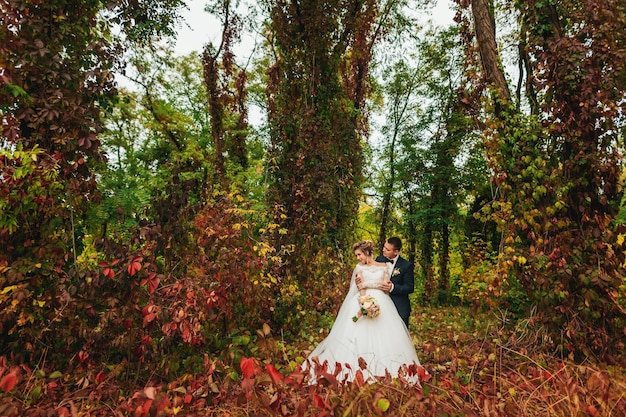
[{"x1": 303, "y1": 264, "x2": 420, "y2": 384}]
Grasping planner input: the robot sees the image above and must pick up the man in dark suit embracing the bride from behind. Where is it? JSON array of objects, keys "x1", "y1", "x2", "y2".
[{"x1": 376, "y1": 237, "x2": 415, "y2": 328}]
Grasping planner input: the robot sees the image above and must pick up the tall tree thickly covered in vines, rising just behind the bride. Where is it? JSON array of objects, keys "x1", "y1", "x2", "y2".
[{"x1": 267, "y1": 0, "x2": 379, "y2": 279}]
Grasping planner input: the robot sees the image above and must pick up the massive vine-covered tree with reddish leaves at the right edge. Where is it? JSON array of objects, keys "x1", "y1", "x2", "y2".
[{"x1": 464, "y1": 0, "x2": 626, "y2": 359}]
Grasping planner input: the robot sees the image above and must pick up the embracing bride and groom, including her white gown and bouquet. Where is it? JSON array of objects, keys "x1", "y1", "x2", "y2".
[{"x1": 306, "y1": 237, "x2": 424, "y2": 384}]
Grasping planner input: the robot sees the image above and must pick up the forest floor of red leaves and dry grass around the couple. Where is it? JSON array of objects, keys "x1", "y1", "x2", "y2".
[{"x1": 0, "y1": 306, "x2": 626, "y2": 417}]
